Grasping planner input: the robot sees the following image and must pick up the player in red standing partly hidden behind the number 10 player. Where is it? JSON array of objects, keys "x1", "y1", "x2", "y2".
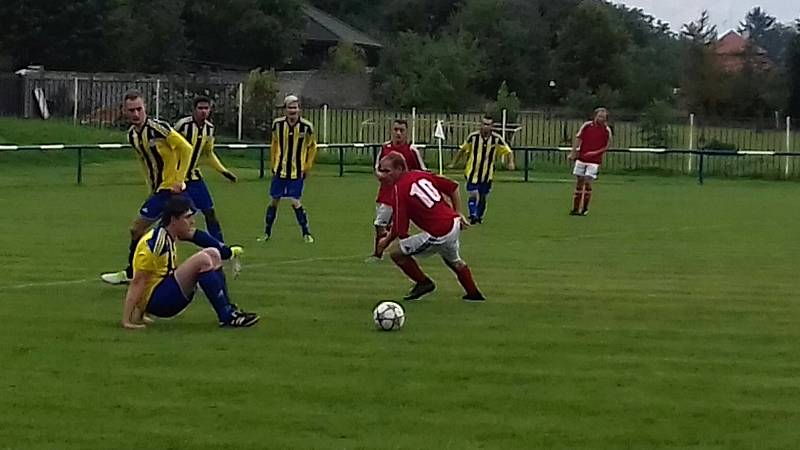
[{"x1": 367, "y1": 119, "x2": 428, "y2": 262}]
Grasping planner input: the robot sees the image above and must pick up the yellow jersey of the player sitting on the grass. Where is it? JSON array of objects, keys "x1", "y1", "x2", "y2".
[{"x1": 133, "y1": 226, "x2": 177, "y2": 311}]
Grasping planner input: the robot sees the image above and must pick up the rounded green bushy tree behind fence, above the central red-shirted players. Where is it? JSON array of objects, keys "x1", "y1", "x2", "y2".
[{"x1": 375, "y1": 33, "x2": 483, "y2": 111}]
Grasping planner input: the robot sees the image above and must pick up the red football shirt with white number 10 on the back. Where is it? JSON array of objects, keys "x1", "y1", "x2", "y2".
[{"x1": 393, "y1": 170, "x2": 459, "y2": 238}]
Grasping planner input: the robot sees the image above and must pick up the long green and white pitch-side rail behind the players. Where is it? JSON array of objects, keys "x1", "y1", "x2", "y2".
[{"x1": 0, "y1": 143, "x2": 800, "y2": 184}]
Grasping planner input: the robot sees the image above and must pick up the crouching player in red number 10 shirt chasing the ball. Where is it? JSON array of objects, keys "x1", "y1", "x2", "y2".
[{"x1": 378, "y1": 152, "x2": 486, "y2": 302}]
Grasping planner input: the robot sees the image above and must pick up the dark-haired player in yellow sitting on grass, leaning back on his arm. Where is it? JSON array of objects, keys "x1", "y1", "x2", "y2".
[{"x1": 122, "y1": 196, "x2": 259, "y2": 329}]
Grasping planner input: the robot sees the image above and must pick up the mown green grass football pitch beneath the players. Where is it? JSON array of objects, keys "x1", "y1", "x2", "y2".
[{"x1": 0, "y1": 154, "x2": 800, "y2": 450}]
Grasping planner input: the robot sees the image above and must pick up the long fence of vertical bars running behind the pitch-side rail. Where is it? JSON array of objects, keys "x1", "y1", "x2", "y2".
[{"x1": 0, "y1": 72, "x2": 800, "y2": 152}]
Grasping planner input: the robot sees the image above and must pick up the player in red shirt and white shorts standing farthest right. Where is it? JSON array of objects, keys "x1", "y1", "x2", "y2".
[{"x1": 567, "y1": 108, "x2": 612, "y2": 216}]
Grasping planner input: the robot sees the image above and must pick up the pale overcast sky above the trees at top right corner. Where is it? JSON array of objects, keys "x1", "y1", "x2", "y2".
[{"x1": 614, "y1": 0, "x2": 800, "y2": 34}]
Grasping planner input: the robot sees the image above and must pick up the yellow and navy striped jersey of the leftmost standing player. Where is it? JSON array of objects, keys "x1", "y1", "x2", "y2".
[{"x1": 128, "y1": 118, "x2": 192, "y2": 192}]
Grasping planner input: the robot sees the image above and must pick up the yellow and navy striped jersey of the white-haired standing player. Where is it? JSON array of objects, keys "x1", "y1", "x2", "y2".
[{"x1": 270, "y1": 117, "x2": 317, "y2": 180}]
